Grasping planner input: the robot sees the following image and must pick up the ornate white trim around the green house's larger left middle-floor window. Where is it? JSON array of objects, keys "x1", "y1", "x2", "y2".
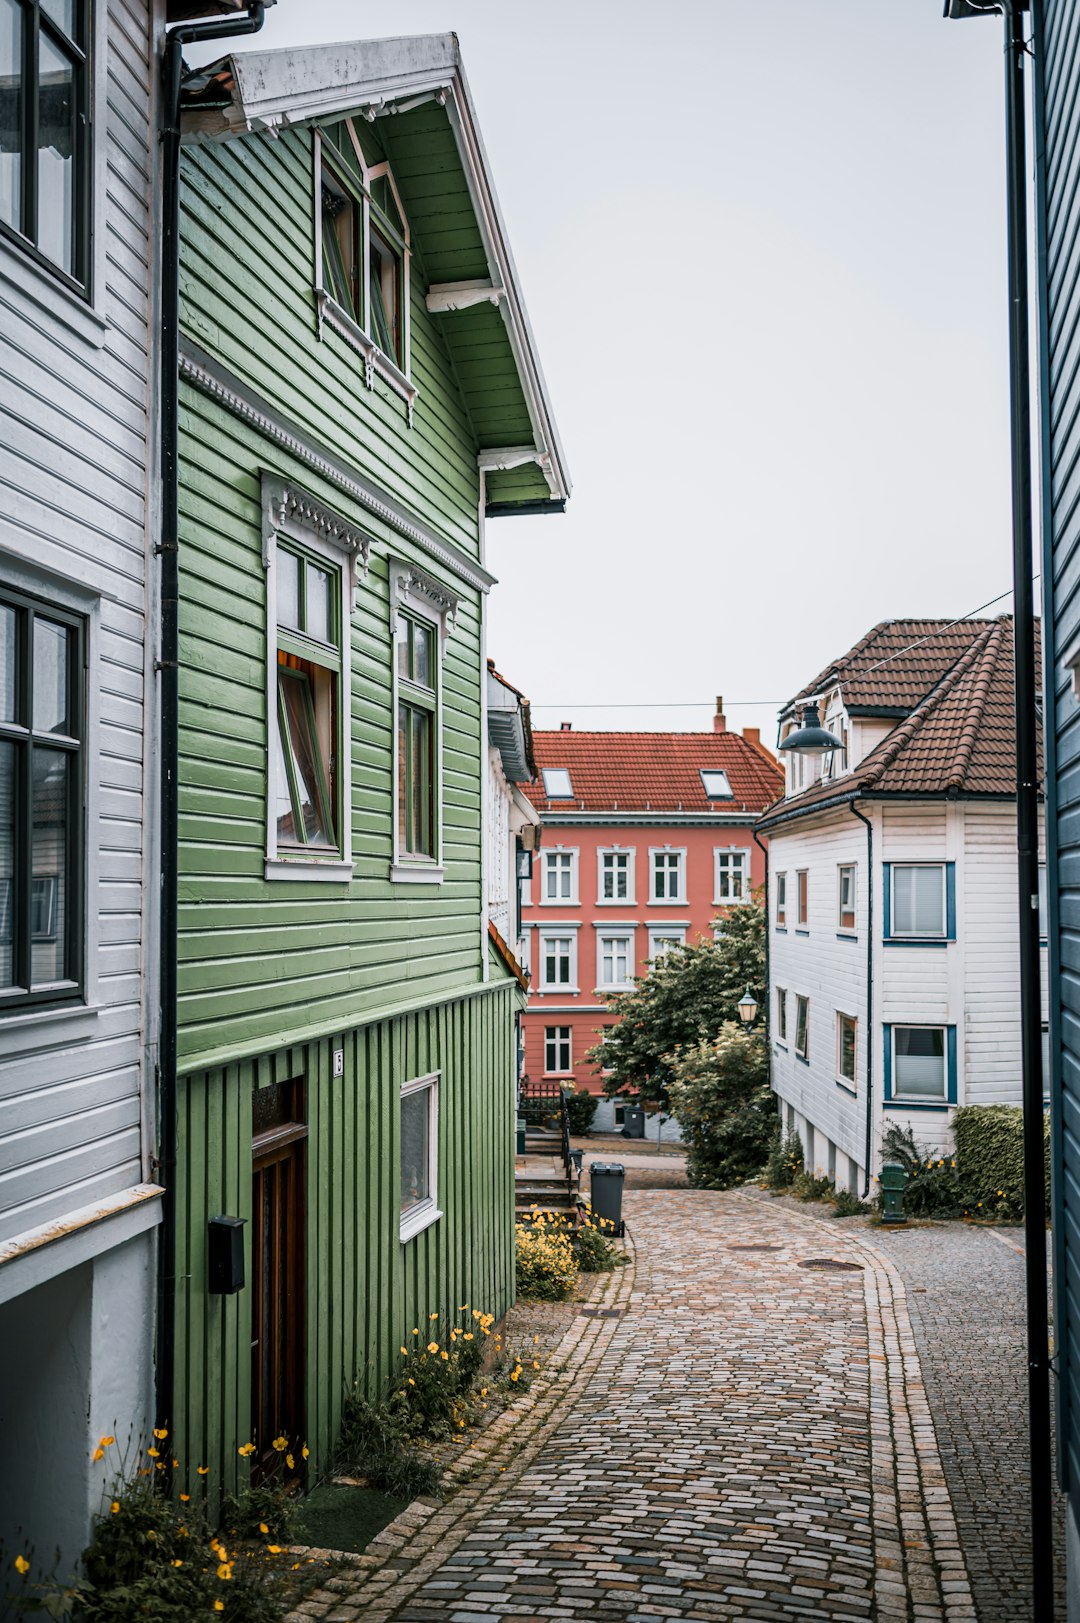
[{"x1": 260, "y1": 469, "x2": 370, "y2": 885}]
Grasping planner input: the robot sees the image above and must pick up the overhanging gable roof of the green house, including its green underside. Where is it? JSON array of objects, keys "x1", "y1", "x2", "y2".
[{"x1": 182, "y1": 34, "x2": 570, "y2": 516}]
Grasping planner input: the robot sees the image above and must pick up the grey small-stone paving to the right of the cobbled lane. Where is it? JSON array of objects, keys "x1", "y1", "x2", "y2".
[{"x1": 874, "y1": 1222, "x2": 1065, "y2": 1623}]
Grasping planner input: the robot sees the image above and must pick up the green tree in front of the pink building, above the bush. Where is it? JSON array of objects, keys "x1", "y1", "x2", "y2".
[{"x1": 588, "y1": 901, "x2": 768, "y2": 1105}]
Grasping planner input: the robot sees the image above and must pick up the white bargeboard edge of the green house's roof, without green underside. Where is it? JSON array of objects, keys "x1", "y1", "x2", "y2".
[{"x1": 182, "y1": 34, "x2": 572, "y2": 514}]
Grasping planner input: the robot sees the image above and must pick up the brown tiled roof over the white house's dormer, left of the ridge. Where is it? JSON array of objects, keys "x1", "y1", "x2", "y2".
[{"x1": 781, "y1": 620, "x2": 997, "y2": 717}]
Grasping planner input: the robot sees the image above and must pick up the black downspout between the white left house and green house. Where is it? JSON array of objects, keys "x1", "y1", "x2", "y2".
[{"x1": 154, "y1": 0, "x2": 264, "y2": 1447}]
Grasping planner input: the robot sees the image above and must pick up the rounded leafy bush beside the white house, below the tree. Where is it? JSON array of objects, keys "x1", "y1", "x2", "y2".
[{"x1": 669, "y1": 1021, "x2": 776, "y2": 1190}]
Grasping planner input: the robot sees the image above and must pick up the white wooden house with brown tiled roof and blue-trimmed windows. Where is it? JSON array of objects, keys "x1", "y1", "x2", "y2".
[{"x1": 757, "y1": 617, "x2": 1039, "y2": 1195}]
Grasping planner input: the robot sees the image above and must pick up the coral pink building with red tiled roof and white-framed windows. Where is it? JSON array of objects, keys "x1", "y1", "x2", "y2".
[{"x1": 521, "y1": 700, "x2": 783, "y2": 1126}]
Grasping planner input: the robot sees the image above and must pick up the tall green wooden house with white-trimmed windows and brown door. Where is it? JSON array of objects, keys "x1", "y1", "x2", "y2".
[{"x1": 164, "y1": 34, "x2": 568, "y2": 1485}]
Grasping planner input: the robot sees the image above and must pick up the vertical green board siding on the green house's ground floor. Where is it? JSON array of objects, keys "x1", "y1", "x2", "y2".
[{"x1": 175, "y1": 982, "x2": 516, "y2": 1488}]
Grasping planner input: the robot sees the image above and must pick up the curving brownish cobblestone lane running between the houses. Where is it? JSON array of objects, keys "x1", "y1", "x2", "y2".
[{"x1": 296, "y1": 1191, "x2": 976, "y2": 1623}]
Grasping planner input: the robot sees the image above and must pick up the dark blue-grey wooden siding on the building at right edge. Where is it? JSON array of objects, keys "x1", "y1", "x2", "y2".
[{"x1": 1033, "y1": 0, "x2": 1080, "y2": 1488}]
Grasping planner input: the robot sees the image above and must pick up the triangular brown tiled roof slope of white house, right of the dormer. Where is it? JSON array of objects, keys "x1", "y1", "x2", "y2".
[{"x1": 758, "y1": 615, "x2": 1041, "y2": 829}]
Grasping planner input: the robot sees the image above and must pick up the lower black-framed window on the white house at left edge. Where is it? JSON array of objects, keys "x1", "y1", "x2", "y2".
[{"x1": 0, "y1": 591, "x2": 86, "y2": 1008}]
